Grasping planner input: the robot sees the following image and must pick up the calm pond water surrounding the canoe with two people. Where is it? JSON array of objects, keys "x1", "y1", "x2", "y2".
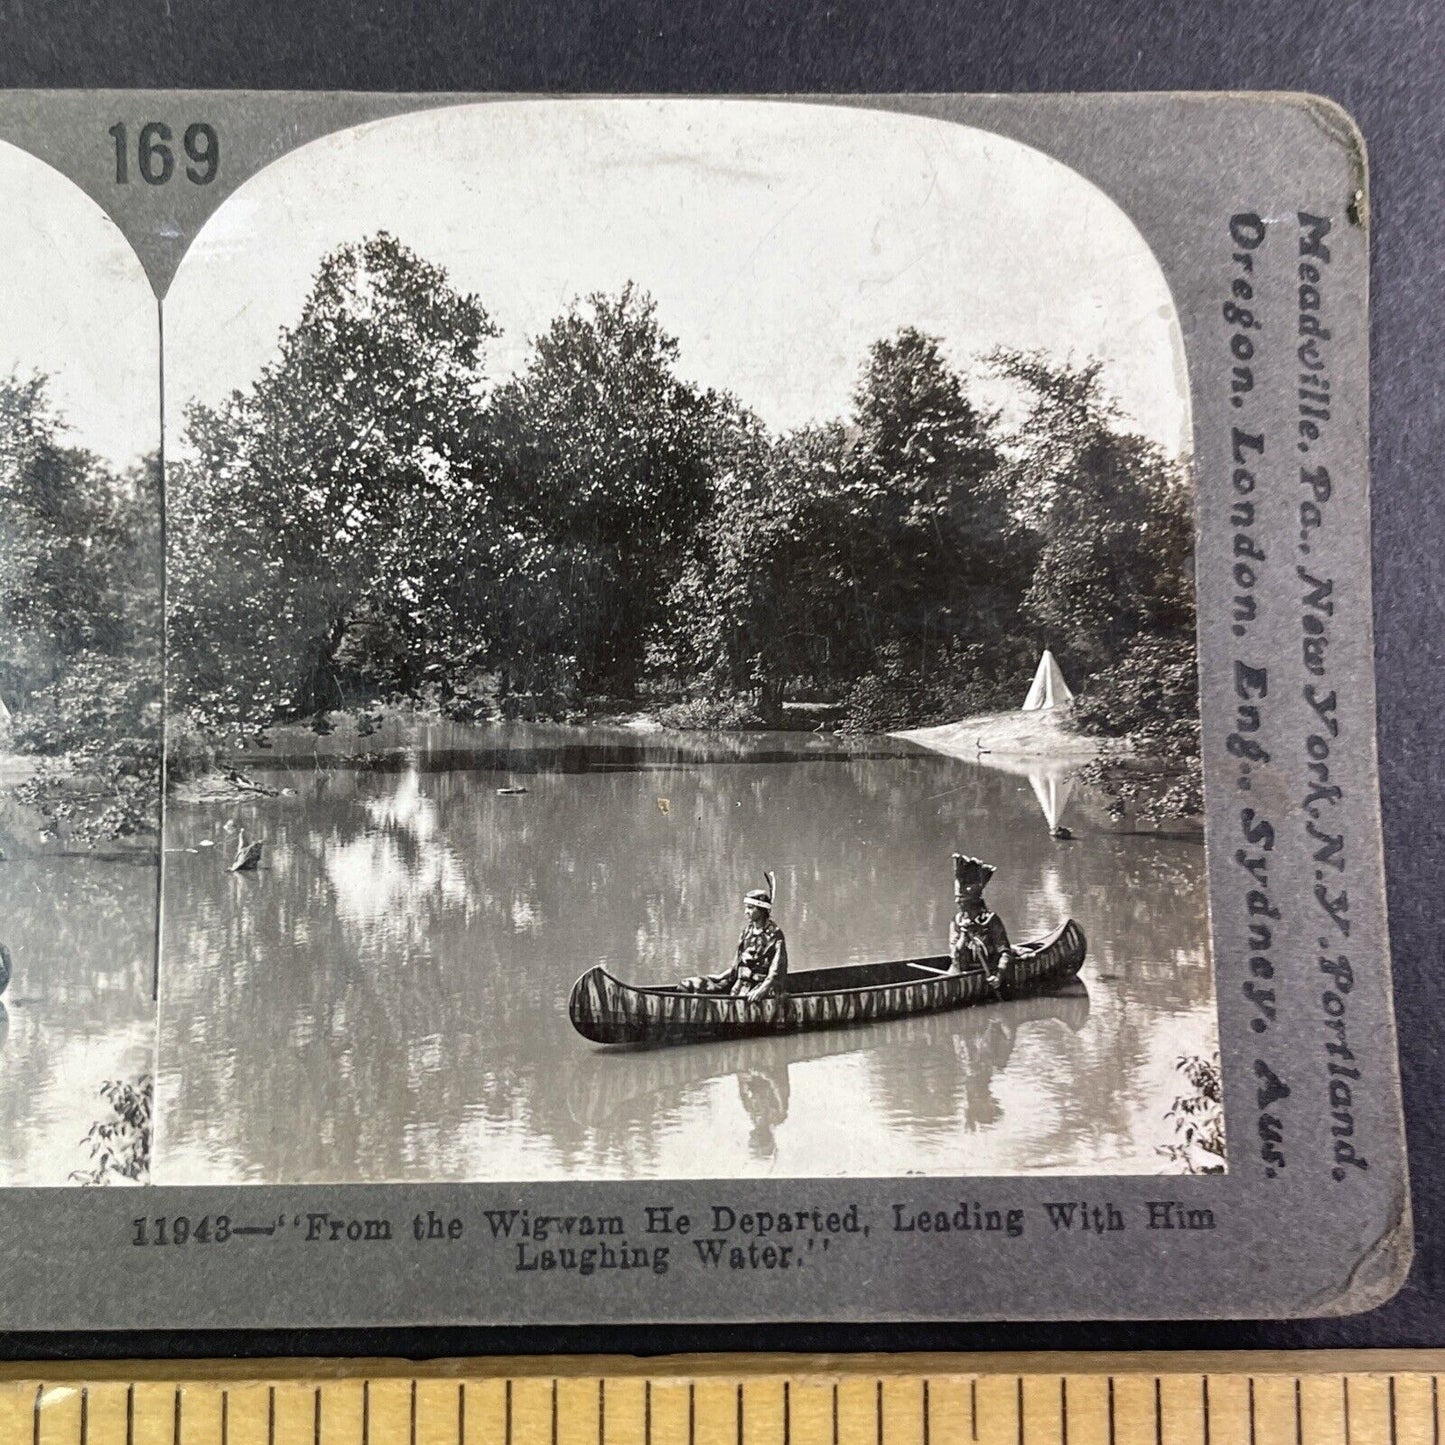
[{"x1": 156, "y1": 724, "x2": 1215, "y2": 1183}]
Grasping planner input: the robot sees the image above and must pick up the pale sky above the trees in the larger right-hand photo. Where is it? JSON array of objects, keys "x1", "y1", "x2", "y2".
[{"x1": 165, "y1": 100, "x2": 1189, "y2": 451}]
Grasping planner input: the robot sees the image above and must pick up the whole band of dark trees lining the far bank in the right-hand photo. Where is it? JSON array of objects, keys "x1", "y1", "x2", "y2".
[{"x1": 169, "y1": 234, "x2": 1196, "y2": 803}]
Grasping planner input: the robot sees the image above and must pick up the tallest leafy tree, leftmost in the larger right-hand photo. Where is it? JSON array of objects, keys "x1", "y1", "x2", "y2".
[{"x1": 169, "y1": 231, "x2": 496, "y2": 730}]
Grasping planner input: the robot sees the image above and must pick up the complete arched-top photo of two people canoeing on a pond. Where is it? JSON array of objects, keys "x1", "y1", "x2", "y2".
[{"x1": 155, "y1": 100, "x2": 1225, "y2": 1185}]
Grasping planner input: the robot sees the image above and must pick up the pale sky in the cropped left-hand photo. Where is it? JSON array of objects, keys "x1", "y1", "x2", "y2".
[{"x1": 0, "y1": 142, "x2": 160, "y2": 467}]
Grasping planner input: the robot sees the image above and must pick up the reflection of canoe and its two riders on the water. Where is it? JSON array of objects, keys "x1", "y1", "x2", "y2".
[{"x1": 568, "y1": 980, "x2": 1090, "y2": 1159}]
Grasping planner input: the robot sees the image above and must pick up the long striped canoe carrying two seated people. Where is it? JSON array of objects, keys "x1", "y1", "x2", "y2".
[{"x1": 566, "y1": 919, "x2": 1085, "y2": 1045}]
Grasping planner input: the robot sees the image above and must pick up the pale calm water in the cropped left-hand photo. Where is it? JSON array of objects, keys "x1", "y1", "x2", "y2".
[{"x1": 0, "y1": 805, "x2": 158, "y2": 1186}]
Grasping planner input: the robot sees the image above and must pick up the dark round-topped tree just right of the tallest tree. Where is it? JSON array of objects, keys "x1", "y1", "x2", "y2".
[{"x1": 491, "y1": 285, "x2": 718, "y2": 692}]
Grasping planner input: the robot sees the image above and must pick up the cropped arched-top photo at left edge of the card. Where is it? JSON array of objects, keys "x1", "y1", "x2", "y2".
[{"x1": 0, "y1": 143, "x2": 162, "y2": 1186}]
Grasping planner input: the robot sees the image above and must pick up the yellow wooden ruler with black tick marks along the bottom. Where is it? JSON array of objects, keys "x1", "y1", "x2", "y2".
[{"x1": 0, "y1": 1351, "x2": 1445, "y2": 1445}]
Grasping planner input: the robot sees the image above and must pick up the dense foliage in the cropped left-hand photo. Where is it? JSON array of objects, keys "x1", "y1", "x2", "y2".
[{"x1": 0, "y1": 377, "x2": 160, "y2": 842}]
